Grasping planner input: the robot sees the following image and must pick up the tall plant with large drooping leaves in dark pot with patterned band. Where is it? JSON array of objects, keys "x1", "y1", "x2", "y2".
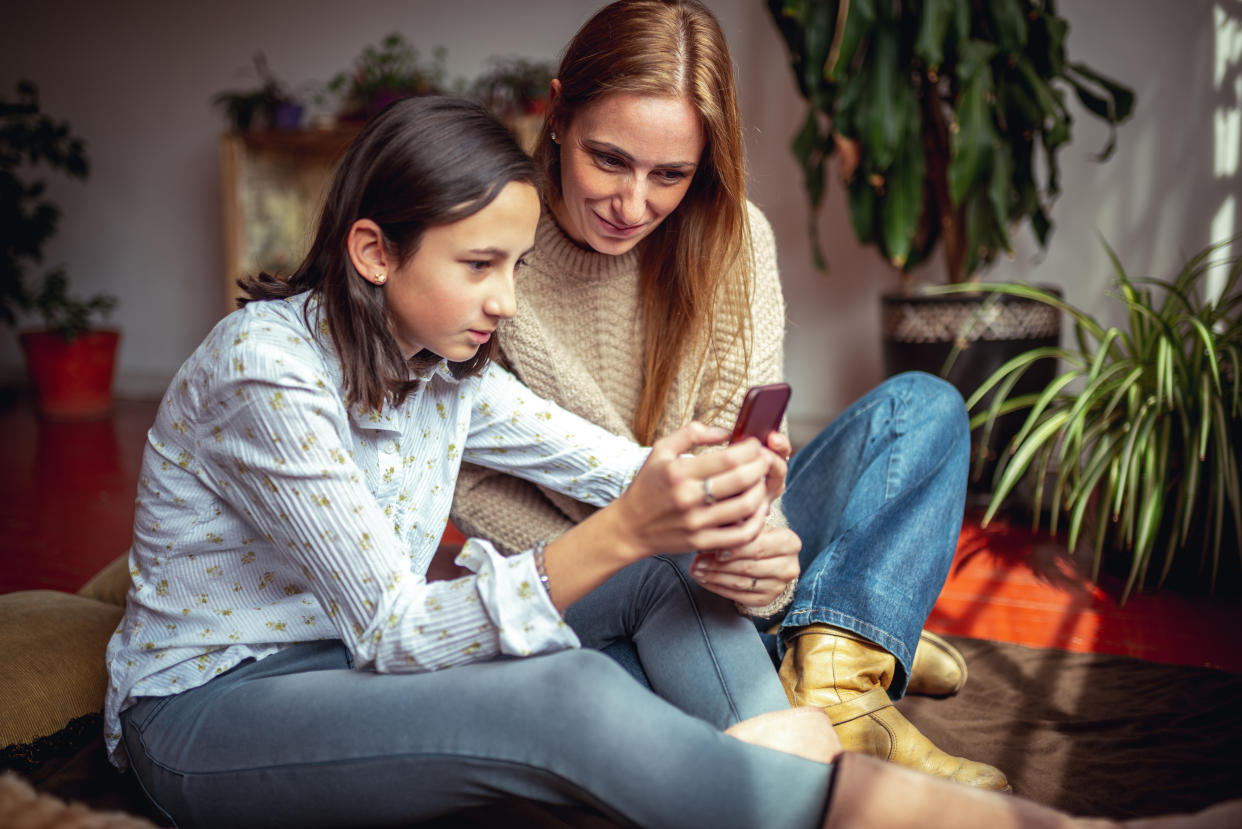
[{"x1": 768, "y1": 0, "x2": 1134, "y2": 483}]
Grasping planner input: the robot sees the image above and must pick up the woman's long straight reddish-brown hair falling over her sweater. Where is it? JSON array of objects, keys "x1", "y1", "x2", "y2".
[{"x1": 534, "y1": 0, "x2": 754, "y2": 444}]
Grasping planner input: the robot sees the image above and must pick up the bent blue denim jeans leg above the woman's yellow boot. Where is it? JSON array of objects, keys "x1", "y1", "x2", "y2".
[{"x1": 780, "y1": 373, "x2": 970, "y2": 698}]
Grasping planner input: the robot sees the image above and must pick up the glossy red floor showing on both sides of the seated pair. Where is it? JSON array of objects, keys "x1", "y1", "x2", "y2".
[{"x1": 0, "y1": 400, "x2": 1242, "y2": 672}]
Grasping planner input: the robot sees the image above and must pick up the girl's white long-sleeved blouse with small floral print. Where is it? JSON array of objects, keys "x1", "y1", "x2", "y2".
[{"x1": 104, "y1": 295, "x2": 648, "y2": 766}]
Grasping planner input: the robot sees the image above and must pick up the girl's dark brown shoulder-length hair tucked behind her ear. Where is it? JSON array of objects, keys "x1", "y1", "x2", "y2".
[{"x1": 238, "y1": 96, "x2": 540, "y2": 410}]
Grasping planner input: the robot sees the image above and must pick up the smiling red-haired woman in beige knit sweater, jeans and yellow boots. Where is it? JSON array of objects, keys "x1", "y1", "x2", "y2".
[{"x1": 453, "y1": 0, "x2": 1009, "y2": 790}]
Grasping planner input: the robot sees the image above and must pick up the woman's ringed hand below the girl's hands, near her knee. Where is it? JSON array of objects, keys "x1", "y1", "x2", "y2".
[{"x1": 691, "y1": 527, "x2": 802, "y2": 608}]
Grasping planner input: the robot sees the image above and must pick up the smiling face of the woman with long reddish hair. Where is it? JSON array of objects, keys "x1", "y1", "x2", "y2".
[{"x1": 551, "y1": 87, "x2": 707, "y2": 256}]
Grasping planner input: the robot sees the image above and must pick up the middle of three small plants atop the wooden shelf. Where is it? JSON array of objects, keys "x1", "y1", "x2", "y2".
[{"x1": 327, "y1": 32, "x2": 447, "y2": 121}]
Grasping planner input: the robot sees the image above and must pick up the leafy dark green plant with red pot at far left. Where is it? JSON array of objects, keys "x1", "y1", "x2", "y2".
[{"x1": 0, "y1": 81, "x2": 120, "y2": 418}]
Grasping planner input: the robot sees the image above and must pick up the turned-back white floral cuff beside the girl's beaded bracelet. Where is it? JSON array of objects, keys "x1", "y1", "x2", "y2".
[{"x1": 456, "y1": 538, "x2": 581, "y2": 656}]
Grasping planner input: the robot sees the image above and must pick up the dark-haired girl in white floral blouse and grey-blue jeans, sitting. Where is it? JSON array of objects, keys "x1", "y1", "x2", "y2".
[{"x1": 106, "y1": 98, "x2": 835, "y2": 827}]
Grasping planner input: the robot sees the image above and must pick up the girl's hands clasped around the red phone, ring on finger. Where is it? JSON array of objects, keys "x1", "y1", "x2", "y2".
[{"x1": 606, "y1": 423, "x2": 770, "y2": 561}]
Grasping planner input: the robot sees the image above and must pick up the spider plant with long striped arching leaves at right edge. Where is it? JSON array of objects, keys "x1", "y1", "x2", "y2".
[{"x1": 929, "y1": 242, "x2": 1242, "y2": 604}]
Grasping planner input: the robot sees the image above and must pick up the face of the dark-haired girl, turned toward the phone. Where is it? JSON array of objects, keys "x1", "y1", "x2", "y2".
[{"x1": 384, "y1": 181, "x2": 539, "y2": 362}]
